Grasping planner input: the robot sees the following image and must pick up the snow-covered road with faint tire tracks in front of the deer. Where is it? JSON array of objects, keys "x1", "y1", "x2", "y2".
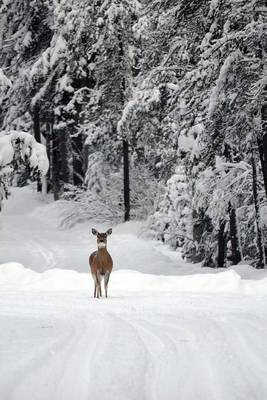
[{"x1": 0, "y1": 291, "x2": 267, "y2": 400}]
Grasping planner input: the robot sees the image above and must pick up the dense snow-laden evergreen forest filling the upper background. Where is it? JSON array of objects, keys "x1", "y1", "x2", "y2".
[{"x1": 0, "y1": 0, "x2": 267, "y2": 268}]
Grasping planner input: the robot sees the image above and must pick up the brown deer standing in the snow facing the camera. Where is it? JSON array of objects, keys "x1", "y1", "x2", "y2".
[{"x1": 89, "y1": 228, "x2": 113, "y2": 298}]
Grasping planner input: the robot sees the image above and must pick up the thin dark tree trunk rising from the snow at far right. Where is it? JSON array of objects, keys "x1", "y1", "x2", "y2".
[{"x1": 251, "y1": 150, "x2": 265, "y2": 268}]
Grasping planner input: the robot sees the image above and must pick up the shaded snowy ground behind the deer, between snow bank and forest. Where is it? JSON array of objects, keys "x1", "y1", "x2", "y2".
[{"x1": 0, "y1": 188, "x2": 185, "y2": 274}]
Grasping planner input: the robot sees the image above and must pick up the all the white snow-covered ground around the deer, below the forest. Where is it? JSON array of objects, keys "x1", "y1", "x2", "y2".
[{"x1": 0, "y1": 188, "x2": 267, "y2": 400}]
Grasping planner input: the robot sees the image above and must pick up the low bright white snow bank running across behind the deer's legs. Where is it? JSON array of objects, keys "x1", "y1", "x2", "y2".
[{"x1": 0, "y1": 263, "x2": 267, "y2": 295}]
